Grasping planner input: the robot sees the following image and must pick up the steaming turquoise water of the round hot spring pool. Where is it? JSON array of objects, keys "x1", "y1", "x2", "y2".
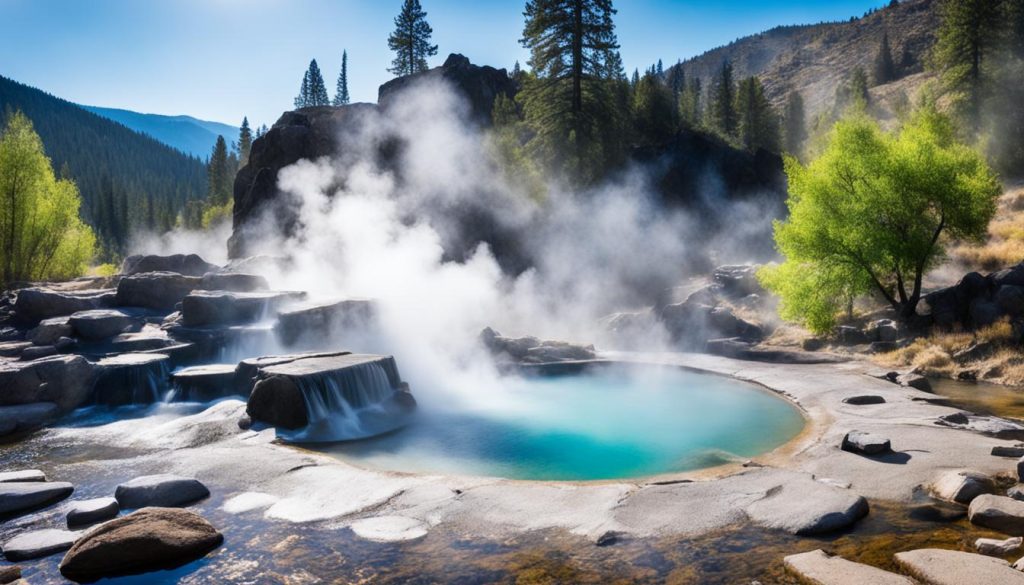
[{"x1": 319, "y1": 368, "x2": 803, "y2": 479}]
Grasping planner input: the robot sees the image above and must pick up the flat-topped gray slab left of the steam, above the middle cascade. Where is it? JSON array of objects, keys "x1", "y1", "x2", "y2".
[{"x1": 181, "y1": 291, "x2": 305, "y2": 327}]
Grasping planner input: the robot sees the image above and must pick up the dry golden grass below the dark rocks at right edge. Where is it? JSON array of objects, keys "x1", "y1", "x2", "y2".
[{"x1": 874, "y1": 321, "x2": 1024, "y2": 385}]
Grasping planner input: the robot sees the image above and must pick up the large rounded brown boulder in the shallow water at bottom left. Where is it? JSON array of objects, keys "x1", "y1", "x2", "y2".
[{"x1": 60, "y1": 508, "x2": 224, "y2": 582}]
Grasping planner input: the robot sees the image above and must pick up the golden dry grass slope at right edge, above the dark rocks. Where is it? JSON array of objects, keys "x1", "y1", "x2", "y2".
[{"x1": 949, "y1": 184, "x2": 1024, "y2": 271}]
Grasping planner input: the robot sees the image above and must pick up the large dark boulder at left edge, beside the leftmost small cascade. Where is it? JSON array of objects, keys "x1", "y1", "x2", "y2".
[{"x1": 0, "y1": 356, "x2": 95, "y2": 412}]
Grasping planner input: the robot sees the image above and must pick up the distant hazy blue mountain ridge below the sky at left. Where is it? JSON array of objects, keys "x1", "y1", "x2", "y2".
[{"x1": 82, "y1": 106, "x2": 239, "y2": 160}]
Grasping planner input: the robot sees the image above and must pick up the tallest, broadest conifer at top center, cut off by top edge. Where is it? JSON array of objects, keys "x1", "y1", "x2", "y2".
[{"x1": 520, "y1": 0, "x2": 623, "y2": 183}]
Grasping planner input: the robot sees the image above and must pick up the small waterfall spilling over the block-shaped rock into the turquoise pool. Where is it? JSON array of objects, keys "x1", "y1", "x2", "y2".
[{"x1": 278, "y1": 360, "x2": 409, "y2": 443}]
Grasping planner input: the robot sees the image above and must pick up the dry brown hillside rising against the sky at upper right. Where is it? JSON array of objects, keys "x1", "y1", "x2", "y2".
[{"x1": 682, "y1": 0, "x2": 939, "y2": 119}]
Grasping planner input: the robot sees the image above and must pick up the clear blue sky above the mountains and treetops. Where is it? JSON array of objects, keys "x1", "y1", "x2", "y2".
[{"x1": 0, "y1": 0, "x2": 886, "y2": 125}]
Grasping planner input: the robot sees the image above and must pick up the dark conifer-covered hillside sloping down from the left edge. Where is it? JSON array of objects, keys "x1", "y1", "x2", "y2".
[{"x1": 0, "y1": 77, "x2": 207, "y2": 258}]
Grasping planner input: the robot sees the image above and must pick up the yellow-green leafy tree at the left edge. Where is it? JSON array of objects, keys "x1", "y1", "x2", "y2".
[{"x1": 0, "y1": 112, "x2": 96, "y2": 286}]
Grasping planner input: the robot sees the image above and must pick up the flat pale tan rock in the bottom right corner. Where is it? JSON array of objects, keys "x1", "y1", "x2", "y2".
[{"x1": 895, "y1": 548, "x2": 1024, "y2": 585}]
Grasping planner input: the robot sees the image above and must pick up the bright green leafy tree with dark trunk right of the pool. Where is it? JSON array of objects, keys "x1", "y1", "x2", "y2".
[{"x1": 759, "y1": 108, "x2": 1001, "y2": 332}]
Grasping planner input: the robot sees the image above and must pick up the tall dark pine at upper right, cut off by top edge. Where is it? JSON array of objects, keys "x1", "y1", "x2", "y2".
[{"x1": 932, "y1": 0, "x2": 999, "y2": 134}]
